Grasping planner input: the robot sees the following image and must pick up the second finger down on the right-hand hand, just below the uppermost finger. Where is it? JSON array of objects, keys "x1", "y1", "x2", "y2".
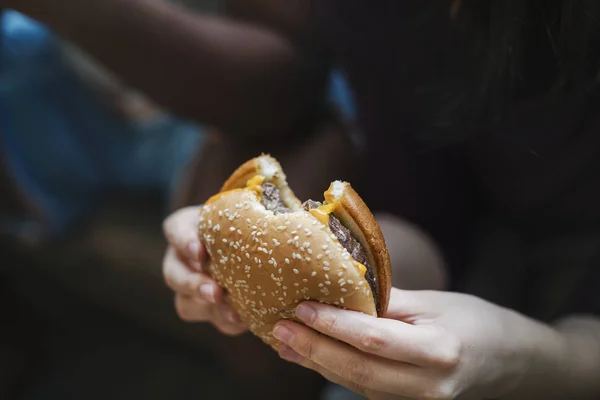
[{"x1": 273, "y1": 321, "x2": 435, "y2": 398}]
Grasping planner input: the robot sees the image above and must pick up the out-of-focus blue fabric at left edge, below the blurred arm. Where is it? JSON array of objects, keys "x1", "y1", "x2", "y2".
[{"x1": 0, "y1": 10, "x2": 202, "y2": 244}]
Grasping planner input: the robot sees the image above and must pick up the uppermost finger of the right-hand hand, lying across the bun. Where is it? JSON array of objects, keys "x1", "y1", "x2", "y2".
[{"x1": 296, "y1": 302, "x2": 460, "y2": 368}]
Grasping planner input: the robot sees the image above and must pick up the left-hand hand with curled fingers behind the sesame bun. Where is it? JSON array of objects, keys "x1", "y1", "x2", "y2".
[{"x1": 163, "y1": 207, "x2": 246, "y2": 335}]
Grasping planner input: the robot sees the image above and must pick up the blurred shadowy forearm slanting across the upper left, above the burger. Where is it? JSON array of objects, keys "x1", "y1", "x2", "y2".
[{"x1": 11, "y1": 0, "x2": 322, "y2": 135}]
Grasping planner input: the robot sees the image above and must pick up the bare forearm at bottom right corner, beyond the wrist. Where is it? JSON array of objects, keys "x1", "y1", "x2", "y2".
[{"x1": 505, "y1": 318, "x2": 600, "y2": 400}]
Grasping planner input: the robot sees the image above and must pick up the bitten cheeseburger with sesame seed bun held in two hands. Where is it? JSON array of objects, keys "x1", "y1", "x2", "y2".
[{"x1": 198, "y1": 155, "x2": 391, "y2": 349}]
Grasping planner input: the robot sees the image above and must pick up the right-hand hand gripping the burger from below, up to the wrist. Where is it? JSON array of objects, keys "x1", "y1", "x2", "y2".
[{"x1": 274, "y1": 289, "x2": 553, "y2": 399}]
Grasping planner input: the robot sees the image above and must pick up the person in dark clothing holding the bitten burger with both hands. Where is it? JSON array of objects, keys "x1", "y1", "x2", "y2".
[{"x1": 5, "y1": 0, "x2": 600, "y2": 399}]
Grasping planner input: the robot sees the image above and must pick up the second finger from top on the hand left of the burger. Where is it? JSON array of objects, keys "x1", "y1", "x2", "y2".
[{"x1": 163, "y1": 246, "x2": 223, "y2": 303}]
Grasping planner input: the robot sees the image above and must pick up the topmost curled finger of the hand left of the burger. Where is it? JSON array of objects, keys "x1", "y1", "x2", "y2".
[{"x1": 163, "y1": 207, "x2": 206, "y2": 261}]
